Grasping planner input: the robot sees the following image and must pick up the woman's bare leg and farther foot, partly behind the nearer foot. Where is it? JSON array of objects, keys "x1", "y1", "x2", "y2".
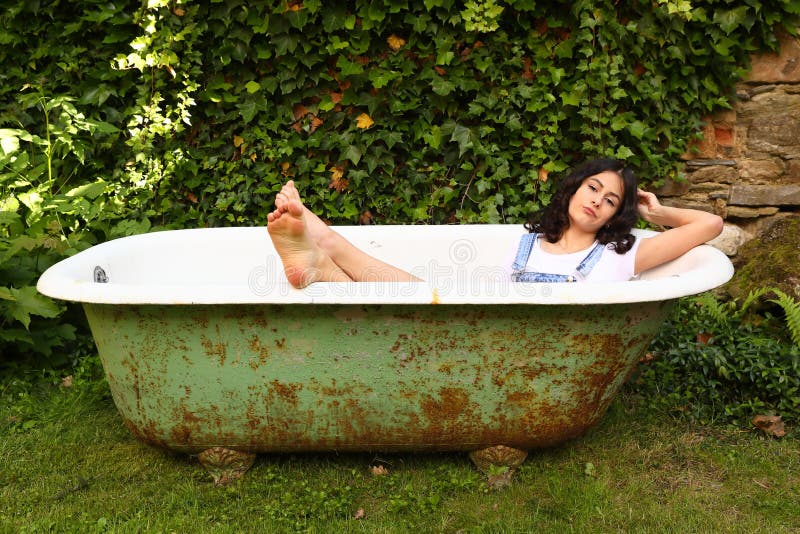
[{"x1": 275, "y1": 181, "x2": 420, "y2": 282}]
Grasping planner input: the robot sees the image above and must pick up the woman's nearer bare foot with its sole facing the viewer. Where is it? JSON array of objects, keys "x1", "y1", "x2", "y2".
[{"x1": 267, "y1": 199, "x2": 350, "y2": 288}]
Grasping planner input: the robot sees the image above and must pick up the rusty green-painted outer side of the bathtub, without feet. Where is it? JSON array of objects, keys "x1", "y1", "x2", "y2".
[{"x1": 84, "y1": 301, "x2": 670, "y2": 453}]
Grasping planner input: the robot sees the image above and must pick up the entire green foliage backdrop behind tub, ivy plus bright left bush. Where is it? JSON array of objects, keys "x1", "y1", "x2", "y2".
[{"x1": 0, "y1": 0, "x2": 800, "y2": 364}]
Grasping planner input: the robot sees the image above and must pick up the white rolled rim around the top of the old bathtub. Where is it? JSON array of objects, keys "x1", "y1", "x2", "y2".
[{"x1": 37, "y1": 225, "x2": 733, "y2": 305}]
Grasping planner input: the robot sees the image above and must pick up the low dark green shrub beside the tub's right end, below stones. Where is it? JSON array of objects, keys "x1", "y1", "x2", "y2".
[{"x1": 631, "y1": 288, "x2": 800, "y2": 426}]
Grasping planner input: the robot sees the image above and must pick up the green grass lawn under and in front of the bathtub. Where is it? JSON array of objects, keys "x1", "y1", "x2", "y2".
[{"x1": 0, "y1": 368, "x2": 800, "y2": 533}]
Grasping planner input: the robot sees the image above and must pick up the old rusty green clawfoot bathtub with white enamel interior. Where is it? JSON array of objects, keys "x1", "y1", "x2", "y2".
[{"x1": 38, "y1": 225, "x2": 733, "y2": 482}]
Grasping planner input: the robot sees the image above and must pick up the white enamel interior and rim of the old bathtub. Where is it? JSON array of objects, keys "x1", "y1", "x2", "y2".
[{"x1": 37, "y1": 225, "x2": 733, "y2": 304}]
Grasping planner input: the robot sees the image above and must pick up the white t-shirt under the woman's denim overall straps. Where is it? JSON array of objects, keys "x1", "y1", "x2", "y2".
[{"x1": 508, "y1": 236, "x2": 642, "y2": 282}]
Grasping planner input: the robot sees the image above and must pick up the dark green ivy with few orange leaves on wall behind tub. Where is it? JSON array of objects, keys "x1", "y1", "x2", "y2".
[{"x1": 104, "y1": 0, "x2": 797, "y2": 225}]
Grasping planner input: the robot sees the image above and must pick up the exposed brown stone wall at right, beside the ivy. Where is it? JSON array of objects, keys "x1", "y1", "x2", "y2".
[{"x1": 656, "y1": 30, "x2": 800, "y2": 256}]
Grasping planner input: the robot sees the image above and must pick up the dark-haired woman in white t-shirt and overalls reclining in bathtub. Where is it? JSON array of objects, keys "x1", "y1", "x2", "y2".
[{"x1": 267, "y1": 159, "x2": 722, "y2": 288}]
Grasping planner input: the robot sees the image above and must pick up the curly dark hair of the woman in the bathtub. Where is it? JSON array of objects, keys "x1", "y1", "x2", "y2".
[{"x1": 525, "y1": 158, "x2": 639, "y2": 254}]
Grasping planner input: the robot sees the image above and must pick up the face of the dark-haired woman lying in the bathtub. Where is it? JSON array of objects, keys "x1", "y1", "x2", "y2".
[{"x1": 569, "y1": 171, "x2": 624, "y2": 233}]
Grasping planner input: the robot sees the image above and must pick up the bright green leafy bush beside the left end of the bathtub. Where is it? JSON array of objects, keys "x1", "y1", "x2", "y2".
[{"x1": 0, "y1": 91, "x2": 146, "y2": 364}]
